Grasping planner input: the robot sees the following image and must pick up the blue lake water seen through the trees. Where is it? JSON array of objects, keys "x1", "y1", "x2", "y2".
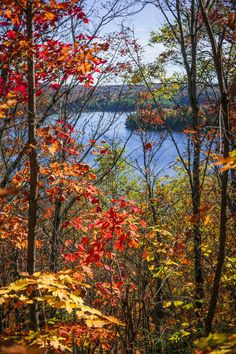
[{"x1": 75, "y1": 112, "x2": 187, "y2": 176}]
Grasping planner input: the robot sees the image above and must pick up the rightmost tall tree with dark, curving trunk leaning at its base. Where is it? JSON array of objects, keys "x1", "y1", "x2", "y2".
[{"x1": 199, "y1": 0, "x2": 235, "y2": 335}]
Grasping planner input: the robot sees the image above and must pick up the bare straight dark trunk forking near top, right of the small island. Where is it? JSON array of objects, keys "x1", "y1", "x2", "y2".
[{"x1": 176, "y1": 0, "x2": 204, "y2": 310}]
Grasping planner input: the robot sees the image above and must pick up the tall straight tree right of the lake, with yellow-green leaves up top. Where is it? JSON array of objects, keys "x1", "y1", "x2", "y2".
[{"x1": 131, "y1": 1, "x2": 208, "y2": 318}]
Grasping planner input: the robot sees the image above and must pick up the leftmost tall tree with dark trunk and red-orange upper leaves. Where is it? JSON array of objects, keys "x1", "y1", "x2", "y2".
[{"x1": 1, "y1": 0, "x2": 105, "y2": 326}]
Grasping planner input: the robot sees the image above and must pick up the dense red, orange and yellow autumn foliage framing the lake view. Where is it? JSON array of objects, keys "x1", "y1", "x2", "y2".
[{"x1": 0, "y1": 0, "x2": 236, "y2": 354}]
